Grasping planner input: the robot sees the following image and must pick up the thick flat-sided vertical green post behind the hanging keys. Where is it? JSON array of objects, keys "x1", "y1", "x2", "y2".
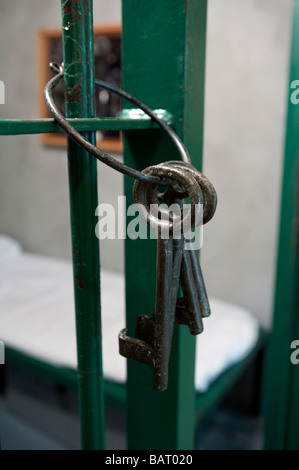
[{"x1": 122, "y1": 0, "x2": 207, "y2": 450}]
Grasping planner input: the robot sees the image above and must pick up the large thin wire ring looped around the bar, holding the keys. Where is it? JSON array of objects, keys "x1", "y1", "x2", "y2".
[{"x1": 44, "y1": 62, "x2": 191, "y2": 185}]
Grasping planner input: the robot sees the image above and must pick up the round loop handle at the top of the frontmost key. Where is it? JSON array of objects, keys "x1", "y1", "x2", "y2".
[{"x1": 133, "y1": 163, "x2": 203, "y2": 234}]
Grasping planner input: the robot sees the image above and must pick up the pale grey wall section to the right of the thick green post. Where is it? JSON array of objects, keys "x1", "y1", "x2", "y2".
[{"x1": 202, "y1": 0, "x2": 292, "y2": 325}]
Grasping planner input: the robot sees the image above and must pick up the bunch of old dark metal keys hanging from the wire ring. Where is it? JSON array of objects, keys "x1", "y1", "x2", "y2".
[{"x1": 119, "y1": 161, "x2": 217, "y2": 391}]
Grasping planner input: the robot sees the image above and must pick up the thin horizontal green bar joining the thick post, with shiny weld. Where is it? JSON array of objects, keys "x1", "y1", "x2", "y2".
[{"x1": 0, "y1": 109, "x2": 172, "y2": 135}]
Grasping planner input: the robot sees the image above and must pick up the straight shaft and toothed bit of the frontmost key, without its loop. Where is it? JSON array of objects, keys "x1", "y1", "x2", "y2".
[{"x1": 119, "y1": 213, "x2": 183, "y2": 391}]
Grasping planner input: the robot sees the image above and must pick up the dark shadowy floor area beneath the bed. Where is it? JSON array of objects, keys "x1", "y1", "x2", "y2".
[{"x1": 0, "y1": 370, "x2": 263, "y2": 450}]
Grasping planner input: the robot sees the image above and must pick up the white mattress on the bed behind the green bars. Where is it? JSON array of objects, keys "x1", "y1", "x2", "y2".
[{"x1": 0, "y1": 237, "x2": 259, "y2": 392}]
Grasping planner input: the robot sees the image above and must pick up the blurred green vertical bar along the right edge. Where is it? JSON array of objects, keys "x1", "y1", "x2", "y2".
[{"x1": 264, "y1": 0, "x2": 299, "y2": 449}]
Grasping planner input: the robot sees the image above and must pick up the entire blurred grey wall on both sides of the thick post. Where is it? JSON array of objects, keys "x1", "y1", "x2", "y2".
[{"x1": 0, "y1": 0, "x2": 292, "y2": 325}]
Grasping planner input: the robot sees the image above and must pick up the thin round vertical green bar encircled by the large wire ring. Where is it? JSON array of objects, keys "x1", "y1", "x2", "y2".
[{"x1": 62, "y1": 0, "x2": 104, "y2": 449}]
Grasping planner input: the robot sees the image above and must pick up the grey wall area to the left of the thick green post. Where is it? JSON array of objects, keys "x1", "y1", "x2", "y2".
[{"x1": 0, "y1": 0, "x2": 123, "y2": 270}]
